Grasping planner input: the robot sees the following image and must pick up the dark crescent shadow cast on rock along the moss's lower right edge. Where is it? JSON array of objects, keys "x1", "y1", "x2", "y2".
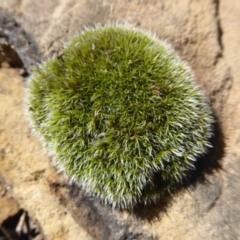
[{"x1": 132, "y1": 112, "x2": 225, "y2": 222}]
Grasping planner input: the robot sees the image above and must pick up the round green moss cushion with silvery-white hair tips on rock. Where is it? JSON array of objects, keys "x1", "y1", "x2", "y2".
[{"x1": 27, "y1": 25, "x2": 212, "y2": 208}]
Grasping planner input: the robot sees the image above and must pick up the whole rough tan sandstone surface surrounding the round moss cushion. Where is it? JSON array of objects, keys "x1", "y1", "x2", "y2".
[{"x1": 0, "y1": 0, "x2": 240, "y2": 240}]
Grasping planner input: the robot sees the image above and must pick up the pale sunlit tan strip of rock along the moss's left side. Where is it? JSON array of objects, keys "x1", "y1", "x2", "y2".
[{"x1": 0, "y1": 65, "x2": 90, "y2": 239}]
